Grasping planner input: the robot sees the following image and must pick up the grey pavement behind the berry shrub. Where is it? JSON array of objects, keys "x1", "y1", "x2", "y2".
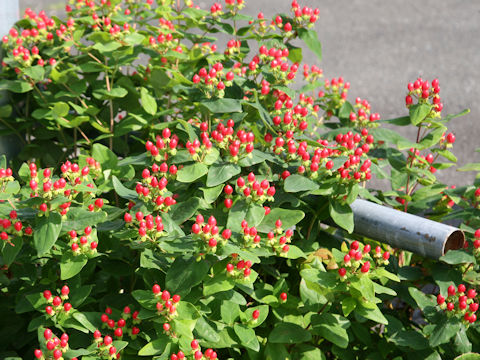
[{"x1": 16, "y1": 0, "x2": 480, "y2": 185}]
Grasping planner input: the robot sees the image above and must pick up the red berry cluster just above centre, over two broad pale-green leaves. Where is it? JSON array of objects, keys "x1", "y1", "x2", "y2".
[{"x1": 209, "y1": 119, "x2": 255, "y2": 163}]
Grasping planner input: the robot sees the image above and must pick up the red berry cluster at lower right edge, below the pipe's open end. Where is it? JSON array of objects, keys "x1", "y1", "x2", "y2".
[{"x1": 437, "y1": 284, "x2": 478, "y2": 325}]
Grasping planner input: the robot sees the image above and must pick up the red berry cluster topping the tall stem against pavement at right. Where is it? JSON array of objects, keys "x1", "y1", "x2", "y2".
[{"x1": 405, "y1": 77, "x2": 443, "y2": 114}]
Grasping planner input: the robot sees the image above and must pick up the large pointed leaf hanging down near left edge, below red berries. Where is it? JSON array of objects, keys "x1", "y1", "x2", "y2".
[{"x1": 33, "y1": 212, "x2": 62, "y2": 256}]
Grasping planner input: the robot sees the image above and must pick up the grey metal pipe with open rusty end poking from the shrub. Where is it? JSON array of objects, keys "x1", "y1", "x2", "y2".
[{"x1": 350, "y1": 199, "x2": 465, "y2": 259}]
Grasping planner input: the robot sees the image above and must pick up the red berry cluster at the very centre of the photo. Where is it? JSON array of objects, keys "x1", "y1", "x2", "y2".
[{"x1": 223, "y1": 172, "x2": 276, "y2": 208}]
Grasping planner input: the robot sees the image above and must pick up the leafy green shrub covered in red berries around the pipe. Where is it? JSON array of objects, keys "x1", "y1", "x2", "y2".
[{"x1": 0, "y1": 0, "x2": 480, "y2": 360}]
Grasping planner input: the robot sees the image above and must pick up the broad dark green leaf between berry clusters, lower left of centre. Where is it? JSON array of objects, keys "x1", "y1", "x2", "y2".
[{"x1": 165, "y1": 256, "x2": 210, "y2": 296}]
